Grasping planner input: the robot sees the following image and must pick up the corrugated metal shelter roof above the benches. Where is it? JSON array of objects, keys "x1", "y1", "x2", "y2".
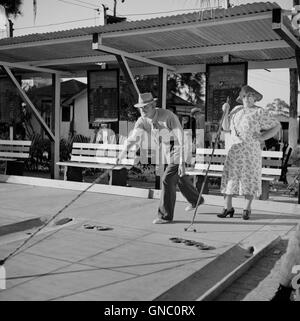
[{"x1": 0, "y1": 2, "x2": 295, "y2": 71}]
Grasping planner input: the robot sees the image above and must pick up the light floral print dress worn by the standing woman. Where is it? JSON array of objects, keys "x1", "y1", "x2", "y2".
[{"x1": 221, "y1": 106, "x2": 279, "y2": 197}]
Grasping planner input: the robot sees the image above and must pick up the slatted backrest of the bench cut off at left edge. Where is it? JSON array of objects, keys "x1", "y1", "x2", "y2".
[{"x1": 0, "y1": 140, "x2": 31, "y2": 160}]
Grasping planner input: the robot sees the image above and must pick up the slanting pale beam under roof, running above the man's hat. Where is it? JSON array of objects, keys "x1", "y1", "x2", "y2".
[{"x1": 92, "y1": 33, "x2": 176, "y2": 71}]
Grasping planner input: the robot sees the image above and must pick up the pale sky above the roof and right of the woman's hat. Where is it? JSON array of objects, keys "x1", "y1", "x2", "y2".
[{"x1": 8, "y1": 0, "x2": 293, "y2": 106}]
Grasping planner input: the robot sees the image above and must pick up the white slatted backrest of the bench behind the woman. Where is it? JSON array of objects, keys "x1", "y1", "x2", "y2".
[{"x1": 195, "y1": 148, "x2": 283, "y2": 176}]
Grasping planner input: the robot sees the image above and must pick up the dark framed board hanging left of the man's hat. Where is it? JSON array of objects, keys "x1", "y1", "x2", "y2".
[{"x1": 88, "y1": 69, "x2": 119, "y2": 124}]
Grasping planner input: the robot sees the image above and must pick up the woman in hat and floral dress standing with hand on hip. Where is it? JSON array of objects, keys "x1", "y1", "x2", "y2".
[{"x1": 218, "y1": 85, "x2": 280, "y2": 220}]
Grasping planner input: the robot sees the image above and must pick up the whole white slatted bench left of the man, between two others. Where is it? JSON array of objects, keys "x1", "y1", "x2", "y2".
[{"x1": 57, "y1": 143, "x2": 137, "y2": 185}]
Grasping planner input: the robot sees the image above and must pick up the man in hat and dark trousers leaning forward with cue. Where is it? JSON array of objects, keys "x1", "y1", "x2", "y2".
[{"x1": 117, "y1": 93, "x2": 204, "y2": 224}]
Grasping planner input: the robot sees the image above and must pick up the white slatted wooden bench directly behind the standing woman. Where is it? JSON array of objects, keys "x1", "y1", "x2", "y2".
[{"x1": 186, "y1": 148, "x2": 283, "y2": 200}]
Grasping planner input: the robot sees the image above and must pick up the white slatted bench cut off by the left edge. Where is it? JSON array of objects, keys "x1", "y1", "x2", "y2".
[{"x1": 0, "y1": 140, "x2": 31, "y2": 175}]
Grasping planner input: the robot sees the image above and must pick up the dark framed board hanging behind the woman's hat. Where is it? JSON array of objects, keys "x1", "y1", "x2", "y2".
[{"x1": 205, "y1": 62, "x2": 248, "y2": 123}]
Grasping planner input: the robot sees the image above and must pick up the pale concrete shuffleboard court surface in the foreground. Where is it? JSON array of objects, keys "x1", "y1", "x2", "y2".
[{"x1": 0, "y1": 183, "x2": 298, "y2": 301}]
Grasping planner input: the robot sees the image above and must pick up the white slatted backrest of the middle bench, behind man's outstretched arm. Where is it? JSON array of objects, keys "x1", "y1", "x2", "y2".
[{"x1": 71, "y1": 143, "x2": 137, "y2": 166}]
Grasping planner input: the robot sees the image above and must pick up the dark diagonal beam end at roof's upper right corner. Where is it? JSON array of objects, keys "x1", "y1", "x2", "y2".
[{"x1": 272, "y1": 8, "x2": 300, "y2": 50}]
